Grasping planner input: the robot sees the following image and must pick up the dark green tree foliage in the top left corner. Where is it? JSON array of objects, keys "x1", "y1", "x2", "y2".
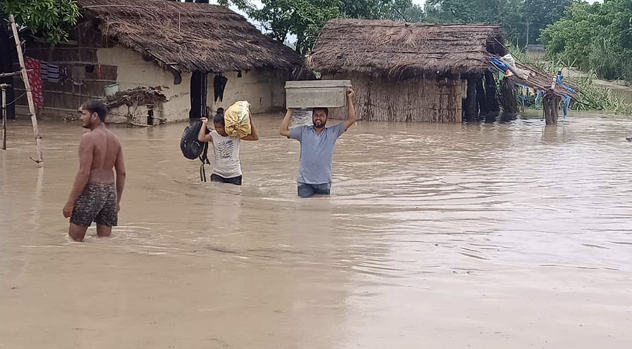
[{"x1": 0, "y1": 0, "x2": 79, "y2": 44}]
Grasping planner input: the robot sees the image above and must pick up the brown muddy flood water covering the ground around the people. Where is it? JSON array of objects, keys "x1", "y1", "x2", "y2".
[{"x1": 0, "y1": 115, "x2": 632, "y2": 349}]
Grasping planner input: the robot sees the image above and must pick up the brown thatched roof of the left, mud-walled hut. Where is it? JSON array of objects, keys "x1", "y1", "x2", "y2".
[{"x1": 77, "y1": 0, "x2": 300, "y2": 73}]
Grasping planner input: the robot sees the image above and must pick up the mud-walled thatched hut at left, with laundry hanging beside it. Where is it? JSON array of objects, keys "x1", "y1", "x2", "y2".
[{"x1": 15, "y1": 0, "x2": 301, "y2": 124}]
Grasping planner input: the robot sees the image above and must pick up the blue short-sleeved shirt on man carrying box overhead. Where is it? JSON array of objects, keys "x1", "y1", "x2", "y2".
[{"x1": 290, "y1": 122, "x2": 345, "y2": 184}]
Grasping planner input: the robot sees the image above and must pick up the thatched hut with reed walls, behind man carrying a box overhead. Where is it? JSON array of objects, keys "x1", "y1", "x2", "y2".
[{"x1": 307, "y1": 19, "x2": 572, "y2": 123}]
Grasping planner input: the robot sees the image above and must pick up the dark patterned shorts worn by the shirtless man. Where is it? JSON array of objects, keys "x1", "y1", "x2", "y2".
[{"x1": 70, "y1": 183, "x2": 118, "y2": 227}]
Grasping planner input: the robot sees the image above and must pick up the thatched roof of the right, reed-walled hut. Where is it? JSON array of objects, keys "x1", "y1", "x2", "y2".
[{"x1": 307, "y1": 19, "x2": 505, "y2": 77}]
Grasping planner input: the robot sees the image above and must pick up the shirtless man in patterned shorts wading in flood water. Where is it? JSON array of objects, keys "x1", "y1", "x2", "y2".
[{"x1": 63, "y1": 101, "x2": 125, "y2": 241}]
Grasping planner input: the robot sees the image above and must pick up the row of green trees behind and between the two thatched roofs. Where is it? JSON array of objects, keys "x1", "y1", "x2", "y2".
[{"x1": 219, "y1": 0, "x2": 573, "y2": 54}]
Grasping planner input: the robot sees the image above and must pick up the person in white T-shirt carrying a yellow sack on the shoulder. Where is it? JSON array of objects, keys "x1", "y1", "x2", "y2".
[{"x1": 198, "y1": 102, "x2": 259, "y2": 185}]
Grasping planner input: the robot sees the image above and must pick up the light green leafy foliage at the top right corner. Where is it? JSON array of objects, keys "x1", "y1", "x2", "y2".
[{"x1": 542, "y1": 0, "x2": 632, "y2": 81}]
